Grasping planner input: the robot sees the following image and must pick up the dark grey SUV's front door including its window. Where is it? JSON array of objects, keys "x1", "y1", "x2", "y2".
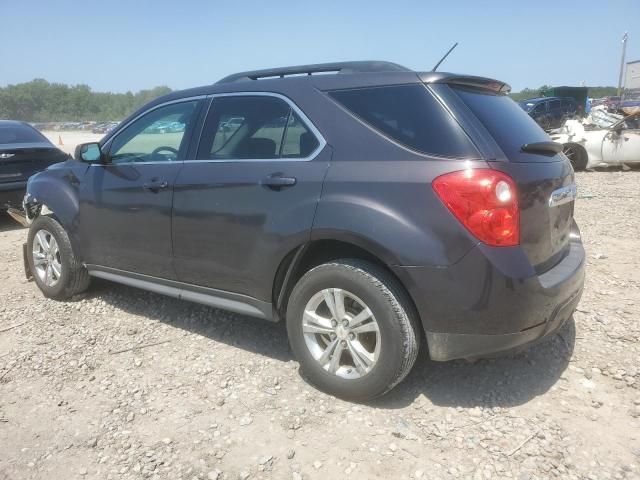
[{"x1": 79, "y1": 99, "x2": 200, "y2": 279}]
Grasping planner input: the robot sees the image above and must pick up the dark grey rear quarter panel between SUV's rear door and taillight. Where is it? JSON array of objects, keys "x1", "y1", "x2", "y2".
[{"x1": 305, "y1": 84, "x2": 487, "y2": 266}]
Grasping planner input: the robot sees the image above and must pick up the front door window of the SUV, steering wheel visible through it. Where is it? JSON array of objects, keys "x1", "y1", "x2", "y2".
[{"x1": 110, "y1": 101, "x2": 197, "y2": 163}]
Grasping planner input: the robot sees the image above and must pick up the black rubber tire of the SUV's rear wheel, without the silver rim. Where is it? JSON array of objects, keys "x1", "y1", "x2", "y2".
[{"x1": 287, "y1": 259, "x2": 420, "y2": 401}]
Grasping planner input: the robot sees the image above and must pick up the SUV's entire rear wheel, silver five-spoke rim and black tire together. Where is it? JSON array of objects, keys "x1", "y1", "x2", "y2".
[{"x1": 287, "y1": 259, "x2": 420, "y2": 401}]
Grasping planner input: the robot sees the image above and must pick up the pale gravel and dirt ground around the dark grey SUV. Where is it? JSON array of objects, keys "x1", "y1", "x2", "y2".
[{"x1": 0, "y1": 172, "x2": 640, "y2": 480}]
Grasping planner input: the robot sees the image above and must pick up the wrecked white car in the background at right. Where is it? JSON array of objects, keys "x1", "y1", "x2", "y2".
[{"x1": 551, "y1": 109, "x2": 640, "y2": 171}]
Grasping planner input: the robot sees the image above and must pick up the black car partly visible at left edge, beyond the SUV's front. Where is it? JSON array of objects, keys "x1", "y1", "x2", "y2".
[{"x1": 0, "y1": 120, "x2": 68, "y2": 211}]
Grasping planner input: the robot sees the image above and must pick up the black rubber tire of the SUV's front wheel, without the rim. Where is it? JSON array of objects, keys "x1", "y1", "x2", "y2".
[{"x1": 27, "y1": 215, "x2": 90, "y2": 300}]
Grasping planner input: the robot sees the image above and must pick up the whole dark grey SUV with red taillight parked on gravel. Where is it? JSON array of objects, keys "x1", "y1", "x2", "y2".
[{"x1": 20, "y1": 62, "x2": 585, "y2": 400}]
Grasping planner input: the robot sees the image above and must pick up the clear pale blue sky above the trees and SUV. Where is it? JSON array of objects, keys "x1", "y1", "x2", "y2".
[{"x1": 0, "y1": 0, "x2": 640, "y2": 92}]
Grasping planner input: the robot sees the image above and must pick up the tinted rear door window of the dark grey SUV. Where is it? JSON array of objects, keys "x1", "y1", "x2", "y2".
[{"x1": 198, "y1": 95, "x2": 318, "y2": 160}]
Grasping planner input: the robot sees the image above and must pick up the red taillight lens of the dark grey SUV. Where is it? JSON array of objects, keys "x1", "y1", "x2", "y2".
[{"x1": 432, "y1": 168, "x2": 520, "y2": 247}]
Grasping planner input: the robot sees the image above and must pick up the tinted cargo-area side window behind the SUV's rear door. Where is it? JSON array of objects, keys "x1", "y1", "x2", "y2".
[{"x1": 329, "y1": 85, "x2": 478, "y2": 158}]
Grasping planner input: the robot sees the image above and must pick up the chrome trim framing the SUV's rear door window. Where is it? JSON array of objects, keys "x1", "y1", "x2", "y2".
[{"x1": 184, "y1": 91, "x2": 327, "y2": 163}]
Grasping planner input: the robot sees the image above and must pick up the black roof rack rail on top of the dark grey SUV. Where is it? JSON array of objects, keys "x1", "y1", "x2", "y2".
[{"x1": 216, "y1": 61, "x2": 412, "y2": 84}]
